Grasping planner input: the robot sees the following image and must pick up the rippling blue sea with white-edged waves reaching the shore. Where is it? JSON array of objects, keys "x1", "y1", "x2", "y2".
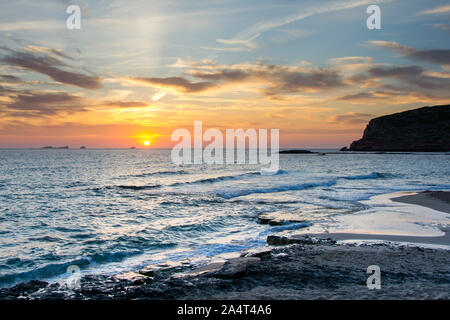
[{"x1": 0, "y1": 149, "x2": 450, "y2": 286}]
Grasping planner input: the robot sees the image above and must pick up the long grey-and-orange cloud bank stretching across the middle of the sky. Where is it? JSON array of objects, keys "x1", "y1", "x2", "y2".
[{"x1": 134, "y1": 60, "x2": 345, "y2": 97}]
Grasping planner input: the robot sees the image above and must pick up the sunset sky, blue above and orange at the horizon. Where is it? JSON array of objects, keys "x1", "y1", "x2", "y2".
[{"x1": 0, "y1": 0, "x2": 450, "y2": 148}]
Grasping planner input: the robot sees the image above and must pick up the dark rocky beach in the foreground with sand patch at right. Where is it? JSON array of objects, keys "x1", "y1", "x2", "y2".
[{"x1": 0, "y1": 191, "x2": 450, "y2": 300}]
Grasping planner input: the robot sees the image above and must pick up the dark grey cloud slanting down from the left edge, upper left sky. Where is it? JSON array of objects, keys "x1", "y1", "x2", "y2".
[{"x1": 0, "y1": 47, "x2": 101, "y2": 89}]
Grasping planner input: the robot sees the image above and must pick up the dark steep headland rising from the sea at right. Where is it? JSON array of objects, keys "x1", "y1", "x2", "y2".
[{"x1": 341, "y1": 105, "x2": 450, "y2": 152}]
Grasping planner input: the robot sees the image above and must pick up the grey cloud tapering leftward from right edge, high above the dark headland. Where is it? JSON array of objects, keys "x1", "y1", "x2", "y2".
[{"x1": 369, "y1": 41, "x2": 450, "y2": 65}]
